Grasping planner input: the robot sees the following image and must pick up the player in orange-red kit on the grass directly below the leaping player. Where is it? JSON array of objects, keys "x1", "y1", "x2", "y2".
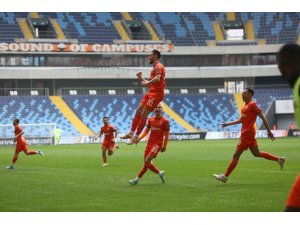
[{"x1": 129, "y1": 104, "x2": 170, "y2": 185}]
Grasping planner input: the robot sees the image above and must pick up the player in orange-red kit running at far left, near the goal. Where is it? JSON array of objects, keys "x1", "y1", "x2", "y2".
[{"x1": 6, "y1": 118, "x2": 44, "y2": 170}]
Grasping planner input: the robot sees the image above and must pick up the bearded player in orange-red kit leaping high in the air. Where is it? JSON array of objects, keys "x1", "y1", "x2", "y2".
[{"x1": 120, "y1": 49, "x2": 166, "y2": 143}]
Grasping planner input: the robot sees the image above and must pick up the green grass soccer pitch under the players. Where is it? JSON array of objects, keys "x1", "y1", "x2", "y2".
[{"x1": 0, "y1": 138, "x2": 300, "y2": 212}]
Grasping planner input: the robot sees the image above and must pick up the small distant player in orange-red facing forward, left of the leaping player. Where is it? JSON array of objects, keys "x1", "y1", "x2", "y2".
[{"x1": 95, "y1": 116, "x2": 119, "y2": 166}]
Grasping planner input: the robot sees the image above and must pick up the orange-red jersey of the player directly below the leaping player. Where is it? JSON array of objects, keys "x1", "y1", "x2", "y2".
[{"x1": 147, "y1": 116, "x2": 170, "y2": 144}]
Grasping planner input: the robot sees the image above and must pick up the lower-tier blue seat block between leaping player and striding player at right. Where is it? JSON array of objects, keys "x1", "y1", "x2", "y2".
[{"x1": 165, "y1": 94, "x2": 240, "y2": 131}]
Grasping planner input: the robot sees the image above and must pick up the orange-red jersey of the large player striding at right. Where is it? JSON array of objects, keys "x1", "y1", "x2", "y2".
[{"x1": 241, "y1": 100, "x2": 261, "y2": 139}]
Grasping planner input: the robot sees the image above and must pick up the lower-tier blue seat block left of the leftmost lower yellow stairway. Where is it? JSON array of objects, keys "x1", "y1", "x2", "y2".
[{"x1": 0, "y1": 96, "x2": 80, "y2": 137}]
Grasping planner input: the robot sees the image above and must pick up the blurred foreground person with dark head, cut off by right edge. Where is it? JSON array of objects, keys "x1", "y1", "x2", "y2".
[{"x1": 277, "y1": 43, "x2": 300, "y2": 212}]
